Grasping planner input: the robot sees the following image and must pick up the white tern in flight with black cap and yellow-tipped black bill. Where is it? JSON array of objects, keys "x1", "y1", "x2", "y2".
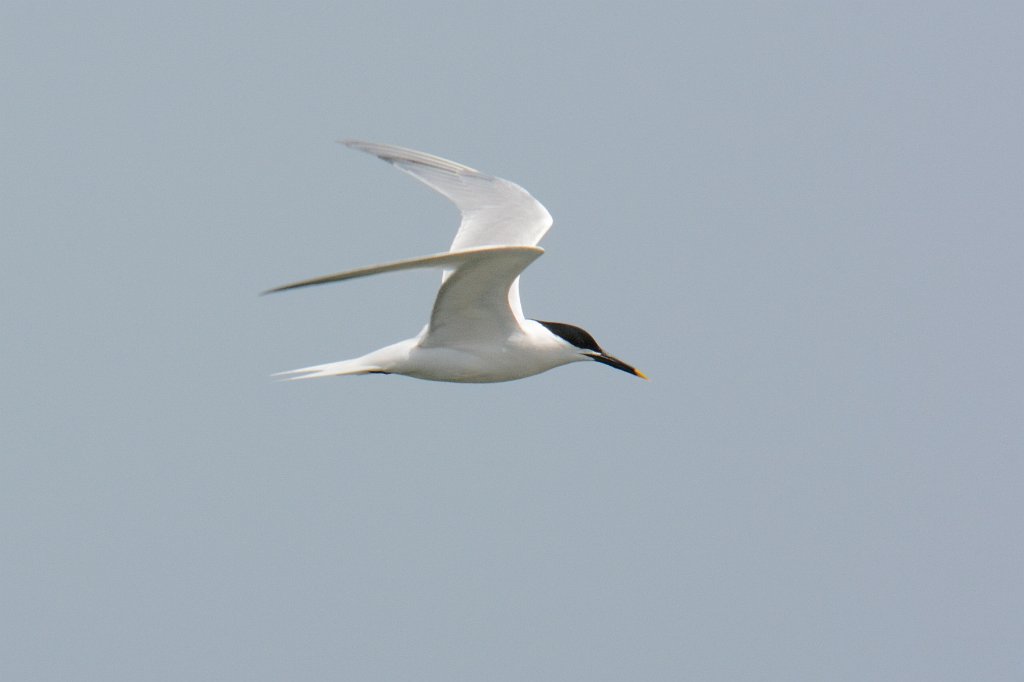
[{"x1": 263, "y1": 139, "x2": 647, "y2": 383}]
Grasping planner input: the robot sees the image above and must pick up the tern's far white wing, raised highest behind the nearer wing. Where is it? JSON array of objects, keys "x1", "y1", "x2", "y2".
[{"x1": 342, "y1": 140, "x2": 552, "y2": 251}]
